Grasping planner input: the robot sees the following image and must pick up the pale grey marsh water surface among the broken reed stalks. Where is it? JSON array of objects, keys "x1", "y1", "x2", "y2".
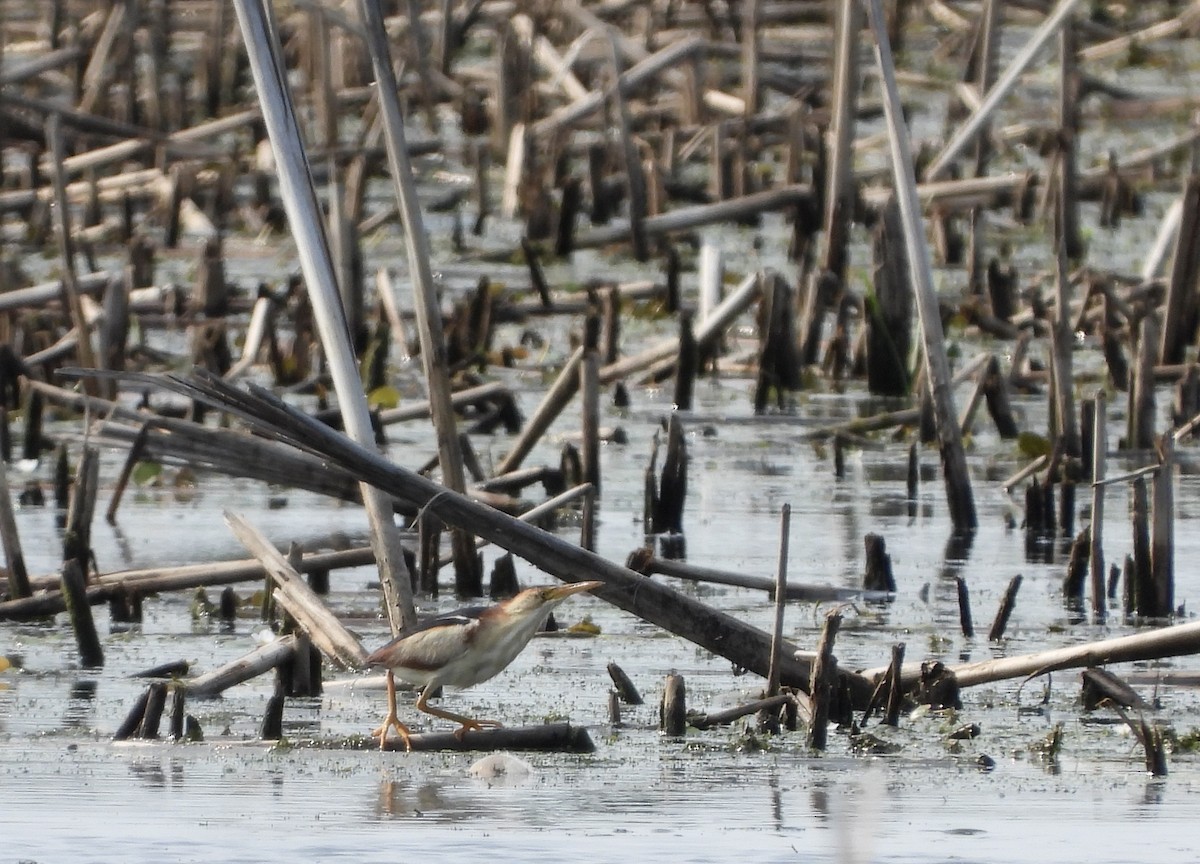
[{"x1": 7, "y1": 11, "x2": 1200, "y2": 864}]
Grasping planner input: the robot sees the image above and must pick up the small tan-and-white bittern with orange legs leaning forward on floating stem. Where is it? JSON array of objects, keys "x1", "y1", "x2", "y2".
[{"x1": 367, "y1": 582, "x2": 605, "y2": 750}]
